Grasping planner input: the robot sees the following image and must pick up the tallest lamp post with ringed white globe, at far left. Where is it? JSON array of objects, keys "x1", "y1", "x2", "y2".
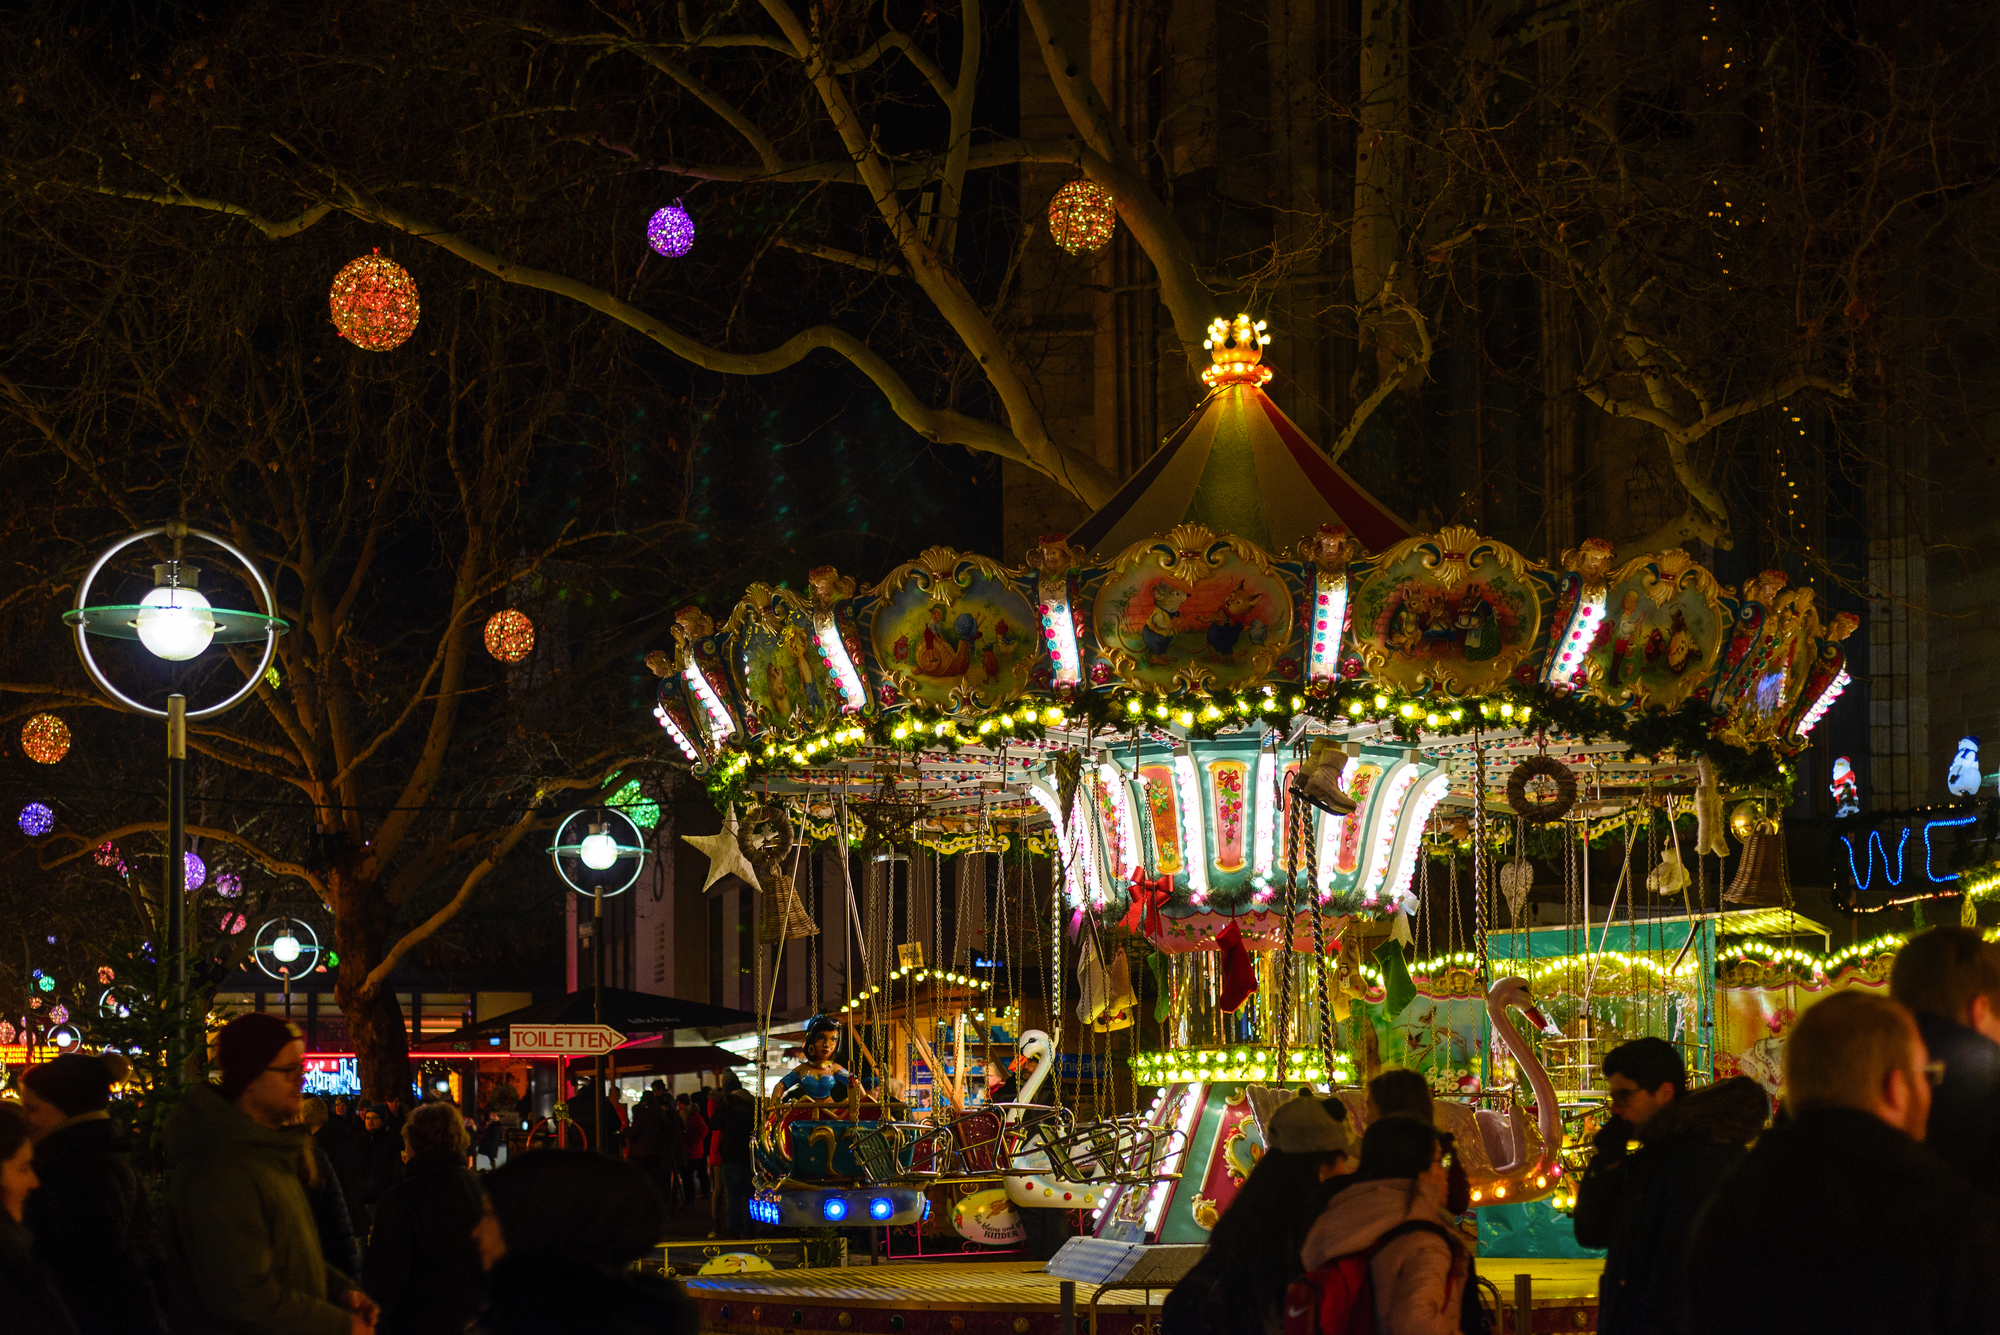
[{"x1": 62, "y1": 522, "x2": 286, "y2": 1079}]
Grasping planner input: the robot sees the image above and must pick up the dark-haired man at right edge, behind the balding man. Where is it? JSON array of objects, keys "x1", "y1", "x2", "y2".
[{"x1": 1888, "y1": 927, "x2": 2000, "y2": 1197}]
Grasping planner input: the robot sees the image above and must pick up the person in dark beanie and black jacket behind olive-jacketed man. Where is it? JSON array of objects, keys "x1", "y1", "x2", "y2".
[{"x1": 20, "y1": 1053, "x2": 166, "y2": 1335}]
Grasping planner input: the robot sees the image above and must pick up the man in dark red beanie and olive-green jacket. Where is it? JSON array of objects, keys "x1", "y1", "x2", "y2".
[{"x1": 166, "y1": 1013, "x2": 378, "y2": 1335}]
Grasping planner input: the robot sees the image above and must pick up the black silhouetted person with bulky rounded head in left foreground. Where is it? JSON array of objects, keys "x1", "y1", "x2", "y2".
[{"x1": 470, "y1": 1149, "x2": 700, "y2": 1335}]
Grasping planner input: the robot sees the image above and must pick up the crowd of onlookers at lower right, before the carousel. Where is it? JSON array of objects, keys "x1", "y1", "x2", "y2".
[{"x1": 1162, "y1": 927, "x2": 2000, "y2": 1335}]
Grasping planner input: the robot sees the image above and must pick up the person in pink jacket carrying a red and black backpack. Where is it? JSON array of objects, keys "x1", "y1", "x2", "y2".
[{"x1": 1284, "y1": 1117, "x2": 1470, "y2": 1335}]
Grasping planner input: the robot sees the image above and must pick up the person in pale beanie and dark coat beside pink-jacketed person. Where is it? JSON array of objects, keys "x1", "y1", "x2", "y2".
[{"x1": 1160, "y1": 1091, "x2": 1354, "y2": 1335}]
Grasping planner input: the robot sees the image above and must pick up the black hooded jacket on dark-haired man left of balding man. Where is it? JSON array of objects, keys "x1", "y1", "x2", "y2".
[{"x1": 1576, "y1": 1075, "x2": 1770, "y2": 1335}]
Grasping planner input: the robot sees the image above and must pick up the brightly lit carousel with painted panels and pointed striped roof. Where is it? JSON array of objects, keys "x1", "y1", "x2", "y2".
[{"x1": 664, "y1": 318, "x2": 1856, "y2": 1329}]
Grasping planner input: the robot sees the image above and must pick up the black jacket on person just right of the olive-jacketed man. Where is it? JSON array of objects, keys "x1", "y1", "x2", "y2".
[{"x1": 362, "y1": 1151, "x2": 482, "y2": 1335}]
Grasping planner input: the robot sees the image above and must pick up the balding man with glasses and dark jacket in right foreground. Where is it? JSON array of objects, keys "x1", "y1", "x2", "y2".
[{"x1": 1686, "y1": 987, "x2": 2000, "y2": 1335}]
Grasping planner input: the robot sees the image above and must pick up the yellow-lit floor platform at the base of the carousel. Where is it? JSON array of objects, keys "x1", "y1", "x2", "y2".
[{"x1": 686, "y1": 1257, "x2": 1604, "y2": 1335}]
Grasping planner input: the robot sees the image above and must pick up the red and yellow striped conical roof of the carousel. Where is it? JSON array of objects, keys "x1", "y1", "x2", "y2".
[{"x1": 1070, "y1": 384, "x2": 1410, "y2": 560}]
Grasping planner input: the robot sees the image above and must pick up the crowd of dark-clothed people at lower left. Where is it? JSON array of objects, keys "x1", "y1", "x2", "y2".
[{"x1": 0, "y1": 1015, "x2": 712, "y2": 1335}]
